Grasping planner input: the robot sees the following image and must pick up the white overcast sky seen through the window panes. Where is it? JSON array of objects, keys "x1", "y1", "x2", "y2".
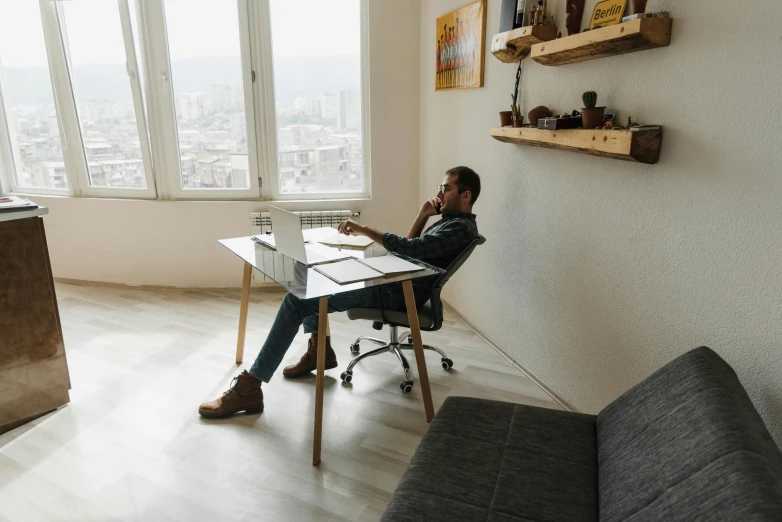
[{"x1": 0, "y1": 0, "x2": 360, "y2": 67}]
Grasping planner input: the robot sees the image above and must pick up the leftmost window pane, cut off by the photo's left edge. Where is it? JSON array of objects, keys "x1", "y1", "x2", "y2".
[{"x1": 0, "y1": 0, "x2": 68, "y2": 190}]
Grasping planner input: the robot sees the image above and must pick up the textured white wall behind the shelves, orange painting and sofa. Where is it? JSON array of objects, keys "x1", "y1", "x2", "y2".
[{"x1": 419, "y1": 0, "x2": 782, "y2": 444}]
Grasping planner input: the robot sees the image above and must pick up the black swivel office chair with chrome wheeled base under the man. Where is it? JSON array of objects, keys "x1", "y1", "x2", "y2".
[{"x1": 340, "y1": 234, "x2": 486, "y2": 393}]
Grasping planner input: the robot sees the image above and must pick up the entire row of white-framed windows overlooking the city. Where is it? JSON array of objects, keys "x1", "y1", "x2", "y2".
[{"x1": 0, "y1": 0, "x2": 369, "y2": 199}]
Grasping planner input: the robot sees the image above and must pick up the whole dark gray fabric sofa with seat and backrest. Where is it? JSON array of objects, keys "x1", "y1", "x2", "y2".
[{"x1": 381, "y1": 347, "x2": 782, "y2": 522}]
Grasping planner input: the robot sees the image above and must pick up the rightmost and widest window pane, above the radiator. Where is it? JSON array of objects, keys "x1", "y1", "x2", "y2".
[{"x1": 271, "y1": 0, "x2": 364, "y2": 194}]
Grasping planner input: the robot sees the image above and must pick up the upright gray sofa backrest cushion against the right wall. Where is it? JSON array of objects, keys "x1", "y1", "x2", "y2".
[{"x1": 597, "y1": 347, "x2": 782, "y2": 522}]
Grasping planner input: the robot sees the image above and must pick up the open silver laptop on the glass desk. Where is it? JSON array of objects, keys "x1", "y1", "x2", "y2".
[{"x1": 269, "y1": 207, "x2": 355, "y2": 266}]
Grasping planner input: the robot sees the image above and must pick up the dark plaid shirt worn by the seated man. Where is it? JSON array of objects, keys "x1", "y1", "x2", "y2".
[{"x1": 383, "y1": 212, "x2": 478, "y2": 268}]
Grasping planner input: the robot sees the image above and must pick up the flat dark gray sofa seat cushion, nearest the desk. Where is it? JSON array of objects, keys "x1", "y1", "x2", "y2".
[{"x1": 382, "y1": 397, "x2": 597, "y2": 522}]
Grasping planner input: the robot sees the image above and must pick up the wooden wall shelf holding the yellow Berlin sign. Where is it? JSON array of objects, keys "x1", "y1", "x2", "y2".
[{"x1": 532, "y1": 18, "x2": 673, "y2": 65}]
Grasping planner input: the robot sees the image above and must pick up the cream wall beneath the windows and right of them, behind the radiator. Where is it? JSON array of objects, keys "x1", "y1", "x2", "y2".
[{"x1": 32, "y1": 0, "x2": 420, "y2": 287}]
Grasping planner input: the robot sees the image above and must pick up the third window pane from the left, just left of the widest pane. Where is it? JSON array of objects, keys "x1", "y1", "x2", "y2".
[{"x1": 165, "y1": 0, "x2": 250, "y2": 189}]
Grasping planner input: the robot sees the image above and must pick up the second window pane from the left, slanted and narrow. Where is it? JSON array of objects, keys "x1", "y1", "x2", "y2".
[{"x1": 62, "y1": 0, "x2": 147, "y2": 189}]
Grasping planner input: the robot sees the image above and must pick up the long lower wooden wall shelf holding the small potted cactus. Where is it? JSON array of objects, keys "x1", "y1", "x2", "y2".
[{"x1": 491, "y1": 126, "x2": 663, "y2": 164}]
